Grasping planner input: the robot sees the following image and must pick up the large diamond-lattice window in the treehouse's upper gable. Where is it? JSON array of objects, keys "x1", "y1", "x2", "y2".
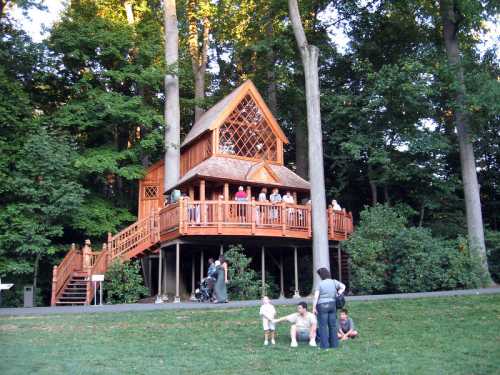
[{"x1": 219, "y1": 95, "x2": 277, "y2": 161}]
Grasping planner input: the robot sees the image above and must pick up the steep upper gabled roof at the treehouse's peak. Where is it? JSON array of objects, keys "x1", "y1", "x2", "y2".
[{"x1": 181, "y1": 80, "x2": 288, "y2": 147}]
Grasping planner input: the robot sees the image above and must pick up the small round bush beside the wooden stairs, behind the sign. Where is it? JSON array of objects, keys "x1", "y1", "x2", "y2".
[{"x1": 104, "y1": 261, "x2": 149, "y2": 303}]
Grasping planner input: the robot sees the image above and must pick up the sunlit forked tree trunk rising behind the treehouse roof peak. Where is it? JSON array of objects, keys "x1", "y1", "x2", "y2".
[{"x1": 187, "y1": 0, "x2": 210, "y2": 122}]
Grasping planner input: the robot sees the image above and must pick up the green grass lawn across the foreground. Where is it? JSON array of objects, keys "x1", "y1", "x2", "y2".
[{"x1": 0, "y1": 295, "x2": 500, "y2": 375}]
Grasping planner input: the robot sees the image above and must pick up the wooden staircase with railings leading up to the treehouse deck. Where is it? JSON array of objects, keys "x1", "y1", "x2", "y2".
[{"x1": 51, "y1": 212, "x2": 160, "y2": 306}]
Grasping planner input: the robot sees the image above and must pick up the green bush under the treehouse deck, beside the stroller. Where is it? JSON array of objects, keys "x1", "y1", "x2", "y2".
[{"x1": 224, "y1": 245, "x2": 277, "y2": 300}]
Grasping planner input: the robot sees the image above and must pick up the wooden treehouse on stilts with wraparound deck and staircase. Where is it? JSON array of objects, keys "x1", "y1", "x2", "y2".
[{"x1": 52, "y1": 81, "x2": 353, "y2": 305}]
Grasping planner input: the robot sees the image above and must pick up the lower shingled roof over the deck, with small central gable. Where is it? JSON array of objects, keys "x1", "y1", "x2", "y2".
[{"x1": 177, "y1": 156, "x2": 311, "y2": 190}]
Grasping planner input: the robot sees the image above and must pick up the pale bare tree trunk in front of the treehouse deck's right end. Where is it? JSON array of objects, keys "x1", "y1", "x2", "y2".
[{"x1": 288, "y1": 0, "x2": 330, "y2": 290}]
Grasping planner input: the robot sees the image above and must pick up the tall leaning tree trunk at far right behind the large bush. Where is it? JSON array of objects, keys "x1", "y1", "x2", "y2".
[{"x1": 439, "y1": 0, "x2": 493, "y2": 284}]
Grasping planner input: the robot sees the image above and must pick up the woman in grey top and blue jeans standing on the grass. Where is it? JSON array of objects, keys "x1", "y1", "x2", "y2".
[{"x1": 313, "y1": 268, "x2": 345, "y2": 349}]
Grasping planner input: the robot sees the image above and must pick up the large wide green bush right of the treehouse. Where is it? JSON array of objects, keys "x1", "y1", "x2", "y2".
[{"x1": 346, "y1": 205, "x2": 481, "y2": 293}]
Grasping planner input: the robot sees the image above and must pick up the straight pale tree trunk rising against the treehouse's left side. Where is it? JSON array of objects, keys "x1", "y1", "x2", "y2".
[{"x1": 163, "y1": 0, "x2": 180, "y2": 190}]
